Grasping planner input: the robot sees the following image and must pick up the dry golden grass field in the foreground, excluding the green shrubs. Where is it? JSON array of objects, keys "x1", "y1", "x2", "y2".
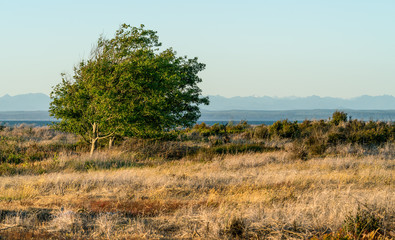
[{"x1": 0, "y1": 150, "x2": 395, "y2": 239}]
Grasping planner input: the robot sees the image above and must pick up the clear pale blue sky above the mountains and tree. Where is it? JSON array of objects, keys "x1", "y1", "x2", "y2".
[{"x1": 0, "y1": 0, "x2": 395, "y2": 98}]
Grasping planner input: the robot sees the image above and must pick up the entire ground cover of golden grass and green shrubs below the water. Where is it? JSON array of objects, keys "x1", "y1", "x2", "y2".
[{"x1": 0, "y1": 112, "x2": 395, "y2": 239}]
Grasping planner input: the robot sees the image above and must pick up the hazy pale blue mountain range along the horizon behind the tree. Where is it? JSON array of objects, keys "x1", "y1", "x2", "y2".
[{"x1": 0, "y1": 93, "x2": 395, "y2": 112}]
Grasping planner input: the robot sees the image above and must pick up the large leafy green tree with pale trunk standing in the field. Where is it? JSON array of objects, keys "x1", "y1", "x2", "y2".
[{"x1": 50, "y1": 24, "x2": 208, "y2": 154}]
